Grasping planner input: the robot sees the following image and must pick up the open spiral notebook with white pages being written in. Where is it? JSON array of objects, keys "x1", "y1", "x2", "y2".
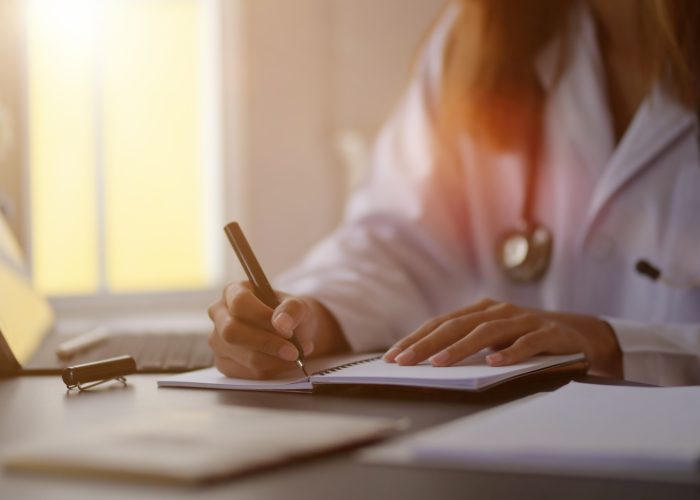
[{"x1": 158, "y1": 351, "x2": 586, "y2": 392}]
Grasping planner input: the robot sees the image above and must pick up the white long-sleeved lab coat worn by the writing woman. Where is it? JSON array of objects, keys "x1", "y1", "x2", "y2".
[{"x1": 278, "y1": 2, "x2": 700, "y2": 385}]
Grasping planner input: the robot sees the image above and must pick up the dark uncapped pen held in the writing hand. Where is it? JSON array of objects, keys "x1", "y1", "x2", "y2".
[{"x1": 224, "y1": 222, "x2": 309, "y2": 377}]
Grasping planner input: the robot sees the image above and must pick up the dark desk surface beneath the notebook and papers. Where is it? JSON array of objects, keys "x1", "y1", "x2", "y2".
[{"x1": 0, "y1": 375, "x2": 700, "y2": 500}]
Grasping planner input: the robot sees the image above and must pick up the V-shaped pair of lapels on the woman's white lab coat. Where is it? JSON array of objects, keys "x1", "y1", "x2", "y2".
[{"x1": 537, "y1": 5, "x2": 694, "y2": 243}]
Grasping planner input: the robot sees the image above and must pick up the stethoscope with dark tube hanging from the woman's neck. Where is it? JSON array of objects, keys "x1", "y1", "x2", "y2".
[{"x1": 496, "y1": 108, "x2": 700, "y2": 288}]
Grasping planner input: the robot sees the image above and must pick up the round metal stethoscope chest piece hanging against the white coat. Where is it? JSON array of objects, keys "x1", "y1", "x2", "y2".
[{"x1": 496, "y1": 222, "x2": 552, "y2": 283}]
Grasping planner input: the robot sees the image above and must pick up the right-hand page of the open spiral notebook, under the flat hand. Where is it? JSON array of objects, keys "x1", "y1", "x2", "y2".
[{"x1": 311, "y1": 351, "x2": 583, "y2": 390}]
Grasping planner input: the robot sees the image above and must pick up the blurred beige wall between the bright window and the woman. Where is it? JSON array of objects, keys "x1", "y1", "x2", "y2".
[{"x1": 224, "y1": 0, "x2": 444, "y2": 274}]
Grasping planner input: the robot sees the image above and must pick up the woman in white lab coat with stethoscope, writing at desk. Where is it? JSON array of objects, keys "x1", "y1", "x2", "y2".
[{"x1": 209, "y1": 0, "x2": 700, "y2": 385}]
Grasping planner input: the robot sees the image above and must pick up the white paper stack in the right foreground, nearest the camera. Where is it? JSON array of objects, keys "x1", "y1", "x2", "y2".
[{"x1": 367, "y1": 382, "x2": 700, "y2": 482}]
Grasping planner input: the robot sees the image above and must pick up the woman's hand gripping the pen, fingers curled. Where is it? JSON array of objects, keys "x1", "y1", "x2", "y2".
[{"x1": 209, "y1": 282, "x2": 347, "y2": 379}]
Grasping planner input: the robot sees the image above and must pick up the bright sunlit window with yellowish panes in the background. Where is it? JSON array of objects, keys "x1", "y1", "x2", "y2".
[{"x1": 26, "y1": 0, "x2": 222, "y2": 296}]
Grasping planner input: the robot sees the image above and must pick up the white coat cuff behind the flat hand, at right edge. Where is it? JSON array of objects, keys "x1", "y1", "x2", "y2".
[{"x1": 605, "y1": 318, "x2": 700, "y2": 386}]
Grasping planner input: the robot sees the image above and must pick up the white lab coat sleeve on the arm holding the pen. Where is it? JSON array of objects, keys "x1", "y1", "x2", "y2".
[{"x1": 276, "y1": 7, "x2": 470, "y2": 351}]
